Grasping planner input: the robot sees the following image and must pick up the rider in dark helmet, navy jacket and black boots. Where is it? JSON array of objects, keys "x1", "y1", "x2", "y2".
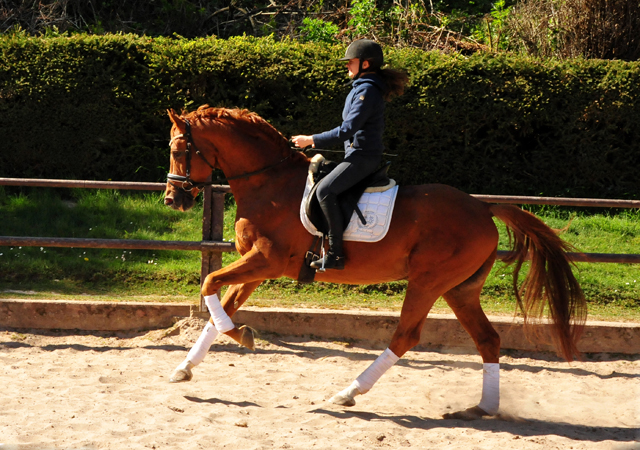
[{"x1": 291, "y1": 39, "x2": 409, "y2": 270}]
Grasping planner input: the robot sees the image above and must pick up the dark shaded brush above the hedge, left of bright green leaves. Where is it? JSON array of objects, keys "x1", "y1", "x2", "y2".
[{"x1": 0, "y1": 0, "x2": 299, "y2": 38}]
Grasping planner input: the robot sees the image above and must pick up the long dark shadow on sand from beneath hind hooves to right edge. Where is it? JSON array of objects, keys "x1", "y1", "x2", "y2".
[{"x1": 309, "y1": 408, "x2": 640, "y2": 442}]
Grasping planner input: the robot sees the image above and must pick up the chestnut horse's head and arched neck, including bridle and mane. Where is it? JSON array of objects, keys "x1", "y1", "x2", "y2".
[{"x1": 164, "y1": 105, "x2": 300, "y2": 211}]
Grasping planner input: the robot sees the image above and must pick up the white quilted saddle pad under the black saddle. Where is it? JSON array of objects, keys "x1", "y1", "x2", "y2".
[{"x1": 300, "y1": 174, "x2": 398, "y2": 242}]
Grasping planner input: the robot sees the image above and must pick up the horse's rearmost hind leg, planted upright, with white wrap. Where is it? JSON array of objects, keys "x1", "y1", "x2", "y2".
[{"x1": 443, "y1": 257, "x2": 500, "y2": 420}]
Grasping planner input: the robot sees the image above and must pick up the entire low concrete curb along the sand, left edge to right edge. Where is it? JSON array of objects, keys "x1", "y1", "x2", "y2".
[{"x1": 0, "y1": 300, "x2": 640, "y2": 354}]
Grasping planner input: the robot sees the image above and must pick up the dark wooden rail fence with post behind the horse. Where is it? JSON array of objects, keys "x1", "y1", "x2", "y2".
[{"x1": 0, "y1": 178, "x2": 640, "y2": 311}]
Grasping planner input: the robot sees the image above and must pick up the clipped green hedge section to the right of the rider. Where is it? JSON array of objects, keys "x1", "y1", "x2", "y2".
[{"x1": 398, "y1": 53, "x2": 640, "y2": 198}]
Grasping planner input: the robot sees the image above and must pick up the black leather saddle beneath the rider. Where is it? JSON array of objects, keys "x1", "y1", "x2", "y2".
[{"x1": 305, "y1": 155, "x2": 396, "y2": 235}]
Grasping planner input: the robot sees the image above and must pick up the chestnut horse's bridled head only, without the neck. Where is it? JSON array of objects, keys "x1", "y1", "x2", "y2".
[{"x1": 164, "y1": 110, "x2": 216, "y2": 211}]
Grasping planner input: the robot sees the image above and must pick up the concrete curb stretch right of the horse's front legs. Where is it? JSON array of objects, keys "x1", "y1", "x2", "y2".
[{"x1": 233, "y1": 308, "x2": 640, "y2": 354}]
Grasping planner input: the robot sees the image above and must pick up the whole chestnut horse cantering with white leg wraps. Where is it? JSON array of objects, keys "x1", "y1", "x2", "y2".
[{"x1": 164, "y1": 105, "x2": 586, "y2": 420}]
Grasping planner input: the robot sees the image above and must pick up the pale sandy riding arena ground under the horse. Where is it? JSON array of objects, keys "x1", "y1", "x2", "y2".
[{"x1": 0, "y1": 318, "x2": 640, "y2": 450}]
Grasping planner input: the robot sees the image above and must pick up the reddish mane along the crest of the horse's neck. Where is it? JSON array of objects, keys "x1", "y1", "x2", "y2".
[{"x1": 183, "y1": 105, "x2": 289, "y2": 151}]
